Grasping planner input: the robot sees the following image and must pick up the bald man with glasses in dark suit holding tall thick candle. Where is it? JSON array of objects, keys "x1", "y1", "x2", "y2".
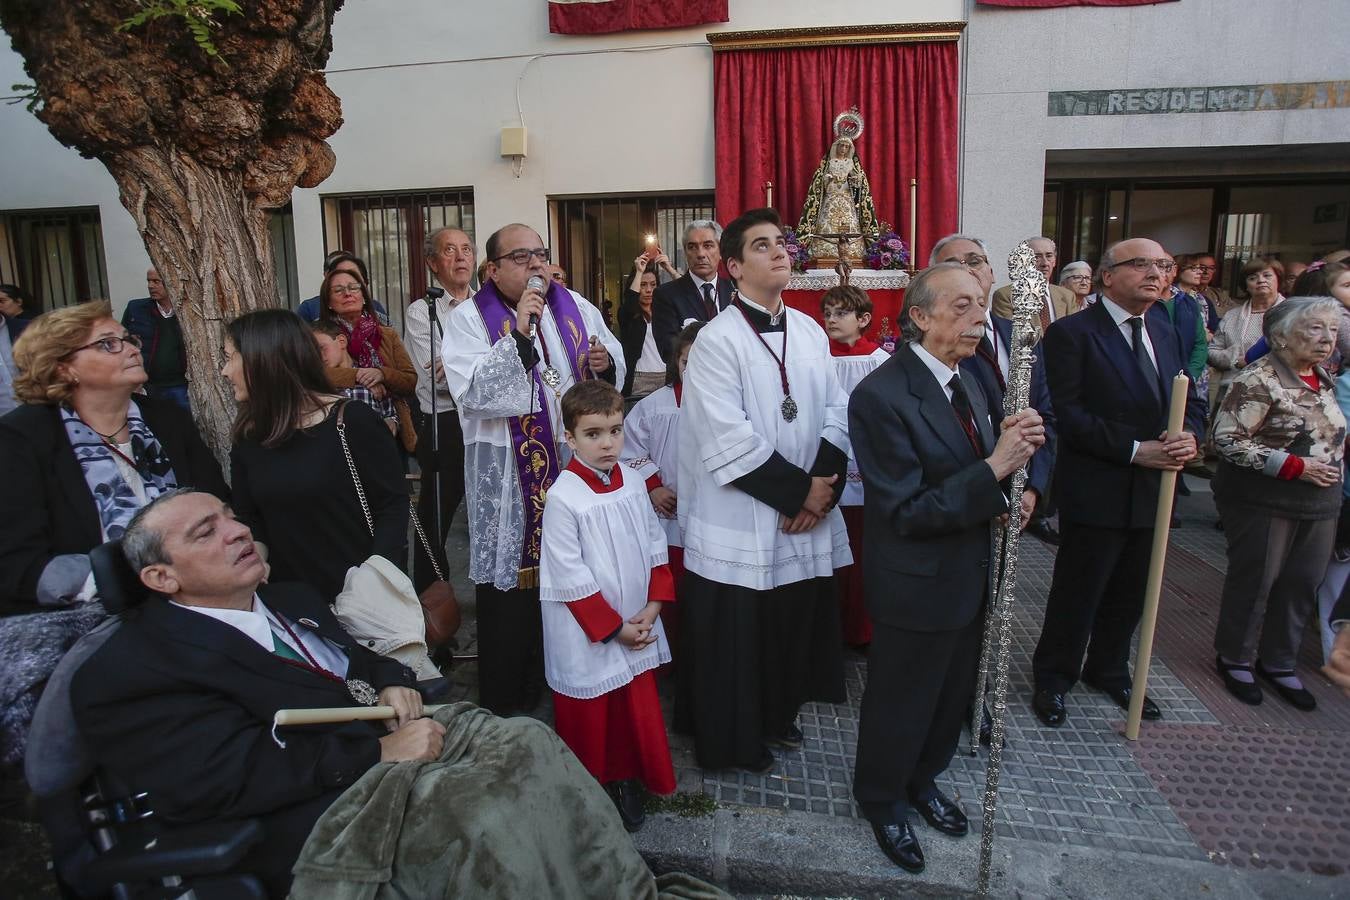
[{"x1": 1031, "y1": 237, "x2": 1204, "y2": 727}]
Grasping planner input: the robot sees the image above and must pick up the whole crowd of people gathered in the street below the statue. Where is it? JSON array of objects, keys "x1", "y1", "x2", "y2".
[{"x1": 0, "y1": 209, "x2": 1350, "y2": 896}]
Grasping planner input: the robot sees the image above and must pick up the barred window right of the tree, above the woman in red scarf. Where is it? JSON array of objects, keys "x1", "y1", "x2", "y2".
[{"x1": 319, "y1": 188, "x2": 477, "y2": 333}]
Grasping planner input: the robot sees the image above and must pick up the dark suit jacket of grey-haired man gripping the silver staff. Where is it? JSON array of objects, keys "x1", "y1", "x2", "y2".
[{"x1": 848, "y1": 344, "x2": 1008, "y2": 631}]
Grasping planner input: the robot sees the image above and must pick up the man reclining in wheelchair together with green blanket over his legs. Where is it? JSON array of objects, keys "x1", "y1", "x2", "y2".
[{"x1": 55, "y1": 491, "x2": 726, "y2": 900}]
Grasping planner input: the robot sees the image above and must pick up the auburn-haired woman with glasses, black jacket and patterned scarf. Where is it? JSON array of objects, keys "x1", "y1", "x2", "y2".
[{"x1": 0, "y1": 301, "x2": 227, "y2": 764}]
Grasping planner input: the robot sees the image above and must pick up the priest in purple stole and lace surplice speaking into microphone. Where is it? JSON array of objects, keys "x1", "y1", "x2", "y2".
[{"x1": 441, "y1": 224, "x2": 624, "y2": 715}]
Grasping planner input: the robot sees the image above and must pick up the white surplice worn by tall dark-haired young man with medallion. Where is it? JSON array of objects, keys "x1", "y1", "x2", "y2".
[{"x1": 679, "y1": 309, "x2": 853, "y2": 591}]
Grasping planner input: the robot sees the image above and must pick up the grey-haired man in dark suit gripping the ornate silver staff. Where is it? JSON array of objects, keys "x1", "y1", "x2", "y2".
[{"x1": 849, "y1": 263, "x2": 1045, "y2": 872}]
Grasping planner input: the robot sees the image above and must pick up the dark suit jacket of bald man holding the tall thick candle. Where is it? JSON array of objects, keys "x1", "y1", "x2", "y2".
[{"x1": 1041, "y1": 302, "x2": 1204, "y2": 528}]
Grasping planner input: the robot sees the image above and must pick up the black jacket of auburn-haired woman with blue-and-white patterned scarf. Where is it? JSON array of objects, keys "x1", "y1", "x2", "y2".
[{"x1": 0, "y1": 395, "x2": 230, "y2": 615}]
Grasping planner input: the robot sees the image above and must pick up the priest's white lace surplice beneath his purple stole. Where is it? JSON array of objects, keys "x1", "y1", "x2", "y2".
[{"x1": 440, "y1": 291, "x2": 624, "y2": 591}]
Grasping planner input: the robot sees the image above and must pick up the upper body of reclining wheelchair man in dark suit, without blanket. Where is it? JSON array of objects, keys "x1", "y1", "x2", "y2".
[{"x1": 72, "y1": 491, "x2": 444, "y2": 896}]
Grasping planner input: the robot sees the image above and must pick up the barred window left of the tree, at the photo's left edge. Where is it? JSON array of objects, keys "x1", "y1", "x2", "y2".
[{"x1": 0, "y1": 208, "x2": 111, "y2": 313}]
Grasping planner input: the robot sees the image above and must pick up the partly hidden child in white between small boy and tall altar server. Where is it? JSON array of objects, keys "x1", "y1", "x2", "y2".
[{"x1": 624, "y1": 322, "x2": 706, "y2": 652}]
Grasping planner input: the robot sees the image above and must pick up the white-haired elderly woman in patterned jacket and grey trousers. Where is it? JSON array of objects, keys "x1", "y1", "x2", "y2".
[{"x1": 1214, "y1": 297, "x2": 1346, "y2": 710}]
